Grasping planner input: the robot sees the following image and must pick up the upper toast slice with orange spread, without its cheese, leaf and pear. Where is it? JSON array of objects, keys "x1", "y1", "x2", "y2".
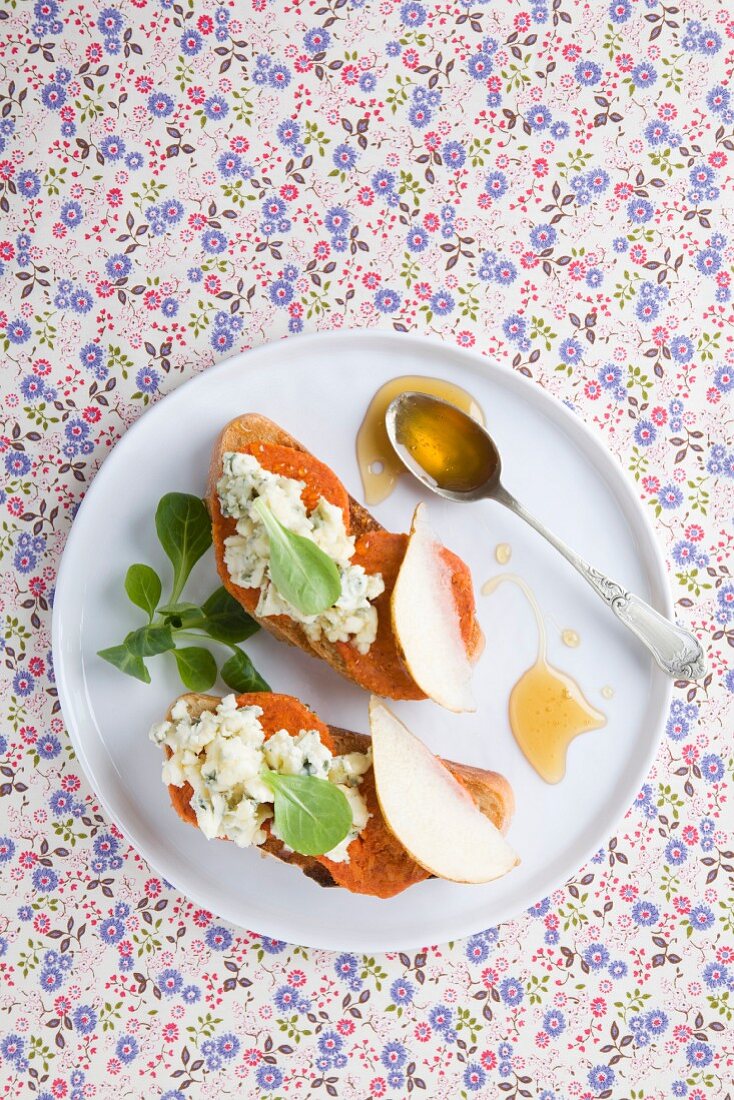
[{"x1": 208, "y1": 413, "x2": 484, "y2": 700}]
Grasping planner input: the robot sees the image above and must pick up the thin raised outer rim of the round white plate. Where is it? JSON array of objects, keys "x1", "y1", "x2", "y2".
[{"x1": 52, "y1": 328, "x2": 675, "y2": 953}]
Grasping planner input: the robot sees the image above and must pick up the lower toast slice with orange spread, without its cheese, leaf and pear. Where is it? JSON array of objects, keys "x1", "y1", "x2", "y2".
[{"x1": 165, "y1": 692, "x2": 515, "y2": 898}]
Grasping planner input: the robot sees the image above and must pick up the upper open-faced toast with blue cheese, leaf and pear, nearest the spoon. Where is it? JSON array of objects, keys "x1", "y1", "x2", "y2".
[{"x1": 208, "y1": 414, "x2": 483, "y2": 711}]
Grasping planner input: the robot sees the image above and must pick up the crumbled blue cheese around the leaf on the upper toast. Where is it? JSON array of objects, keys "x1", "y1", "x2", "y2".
[{"x1": 217, "y1": 451, "x2": 385, "y2": 653}]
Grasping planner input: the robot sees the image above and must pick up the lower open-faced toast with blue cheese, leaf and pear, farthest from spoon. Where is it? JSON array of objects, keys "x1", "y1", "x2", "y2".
[{"x1": 151, "y1": 692, "x2": 518, "y2": 898}]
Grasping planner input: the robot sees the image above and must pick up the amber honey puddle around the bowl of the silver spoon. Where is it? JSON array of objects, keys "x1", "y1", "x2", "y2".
[{"x1": 357, "y1": 374, "x2": 485, "y2": 504}]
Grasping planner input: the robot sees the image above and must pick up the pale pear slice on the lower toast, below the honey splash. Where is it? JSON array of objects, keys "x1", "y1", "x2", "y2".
[{"x1": 370, "y1": 695, "x2": 519, "y2": 882}]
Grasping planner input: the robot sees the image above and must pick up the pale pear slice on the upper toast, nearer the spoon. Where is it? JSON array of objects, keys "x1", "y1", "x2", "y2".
[{"x1": 390, "y1": 504, "x2": 476, "y2": 712}]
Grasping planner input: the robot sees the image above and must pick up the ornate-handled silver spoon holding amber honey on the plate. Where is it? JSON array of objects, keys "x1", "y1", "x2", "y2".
[{"x1": 385, "y1": 392, "x2": 705, "y2": 680}]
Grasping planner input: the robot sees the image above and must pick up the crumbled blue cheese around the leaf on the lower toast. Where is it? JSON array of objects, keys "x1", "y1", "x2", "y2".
[{"x1": 150, "y1": 695, "x2": 372, "y2": 862}]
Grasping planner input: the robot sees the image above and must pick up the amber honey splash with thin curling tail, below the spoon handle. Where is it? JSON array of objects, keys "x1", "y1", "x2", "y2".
[{"x1": 482, "y1": 573, "x2": 606, "y2": 783}]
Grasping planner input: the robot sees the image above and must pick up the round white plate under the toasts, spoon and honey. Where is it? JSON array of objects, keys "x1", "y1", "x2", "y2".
[{"x1": 54, "y1": 330, "x2": 671, "y2": 952}]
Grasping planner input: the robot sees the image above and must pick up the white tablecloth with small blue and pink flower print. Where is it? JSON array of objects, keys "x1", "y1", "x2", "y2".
[{"x1": 0, "y1": 0, "x2": 734, "y2": 1100}]
